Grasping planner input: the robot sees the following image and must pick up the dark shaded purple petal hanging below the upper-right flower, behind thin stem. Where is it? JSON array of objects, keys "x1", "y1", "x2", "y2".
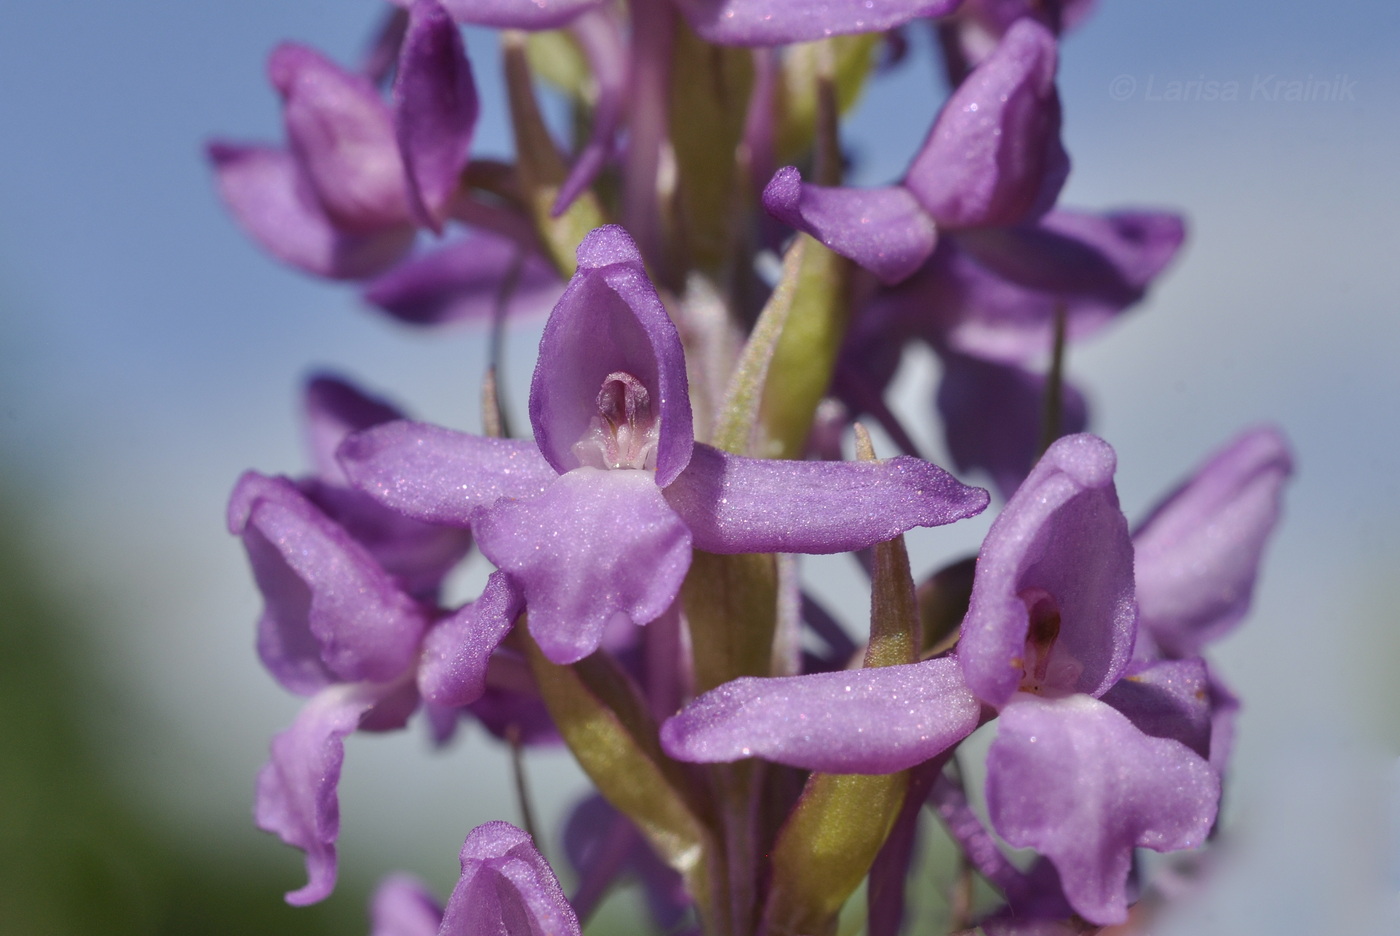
[{"x1": 938, "y1": 351, "x2": 1089, "y2": 499}]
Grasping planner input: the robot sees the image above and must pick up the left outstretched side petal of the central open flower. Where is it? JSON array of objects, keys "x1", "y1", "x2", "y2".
[{"x1": 339, "y1": 421, "x2": 557, "y2": 526}]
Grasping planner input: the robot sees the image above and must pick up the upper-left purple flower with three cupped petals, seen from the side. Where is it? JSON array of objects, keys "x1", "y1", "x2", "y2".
[{"x1": 209, "y1": 0, "x2": 477, "y2": 278}]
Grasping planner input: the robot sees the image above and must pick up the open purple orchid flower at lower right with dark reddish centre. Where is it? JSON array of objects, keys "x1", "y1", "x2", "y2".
[{"x1": 661, "y1": 435, "x2": 1219, "y2": 925}]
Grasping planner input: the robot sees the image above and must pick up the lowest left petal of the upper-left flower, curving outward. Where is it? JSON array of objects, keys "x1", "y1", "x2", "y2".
[{"x1": 209, "y1": 143, "x2": 413, "y2": 280}]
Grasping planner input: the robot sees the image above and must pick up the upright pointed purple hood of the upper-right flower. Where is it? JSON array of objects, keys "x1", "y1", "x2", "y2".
[{"x1": 904, "y1": 20, "x2": 1070, "y2": 228}]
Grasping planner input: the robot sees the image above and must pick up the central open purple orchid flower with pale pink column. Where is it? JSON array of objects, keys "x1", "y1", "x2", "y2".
[{"x1": 340, "y1": 227, "x2": 987, "y2": 683}]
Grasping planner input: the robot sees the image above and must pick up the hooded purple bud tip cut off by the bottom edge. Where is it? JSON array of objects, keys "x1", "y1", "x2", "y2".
[{"x1": 440, "y1": 821, "x2": 580, "y2": 936}]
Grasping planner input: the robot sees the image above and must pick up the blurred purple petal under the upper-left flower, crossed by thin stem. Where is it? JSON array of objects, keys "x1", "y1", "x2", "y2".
[{"x1": 364, "y1": 231, "x2": 564, "y2": 325}]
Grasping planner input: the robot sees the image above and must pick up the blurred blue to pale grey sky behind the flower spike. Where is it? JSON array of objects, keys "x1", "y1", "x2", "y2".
[{"x1": 0, "y1": 0, "x2": 1400, "y2": 935}]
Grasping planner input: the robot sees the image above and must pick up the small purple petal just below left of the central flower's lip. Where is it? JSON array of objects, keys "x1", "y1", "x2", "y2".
[{"x1": 419, "y1": 572, "x2": 525, "y2": 708}]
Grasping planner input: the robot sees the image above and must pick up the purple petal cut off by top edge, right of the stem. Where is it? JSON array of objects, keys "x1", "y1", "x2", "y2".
[{"x1": 679, "y1": 0, "x2": 960, "y2": 46}]
